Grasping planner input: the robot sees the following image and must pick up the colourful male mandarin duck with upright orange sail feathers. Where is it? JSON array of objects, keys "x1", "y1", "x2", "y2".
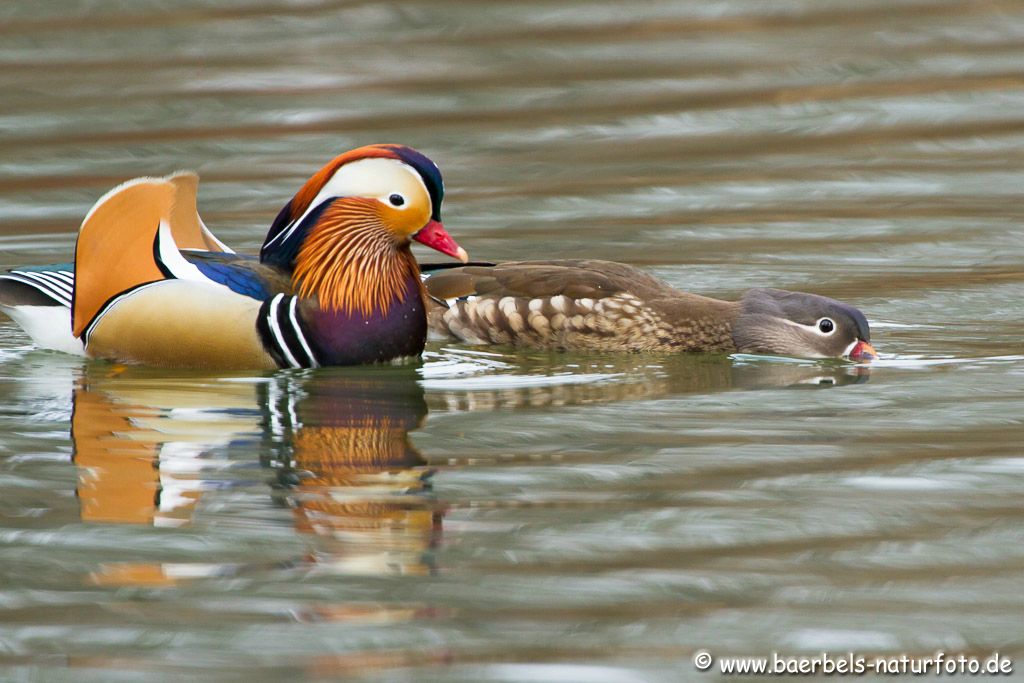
[{"x1": 0, "y1": 144, "x2": 468, "y2": 370}]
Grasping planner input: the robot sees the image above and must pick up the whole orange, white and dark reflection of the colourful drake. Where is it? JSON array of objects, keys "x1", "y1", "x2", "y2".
[{"x1": 72, "y1": 365, "x2": 440, "y2": 584}]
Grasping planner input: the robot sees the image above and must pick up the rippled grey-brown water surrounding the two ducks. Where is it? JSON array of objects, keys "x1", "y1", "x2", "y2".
[{"x1": 0, "y1": 0, "x2": 1024, "y2": 681}]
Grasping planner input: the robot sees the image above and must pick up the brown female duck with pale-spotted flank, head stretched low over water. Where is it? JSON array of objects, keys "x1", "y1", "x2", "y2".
[{"x1": 424, "y1": 260, "x2": 877, "y2": 360}]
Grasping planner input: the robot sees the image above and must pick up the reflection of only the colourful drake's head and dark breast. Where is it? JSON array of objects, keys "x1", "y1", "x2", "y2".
[{"x1": 263, "y1": 369, "x2": 440, "y2": 573}]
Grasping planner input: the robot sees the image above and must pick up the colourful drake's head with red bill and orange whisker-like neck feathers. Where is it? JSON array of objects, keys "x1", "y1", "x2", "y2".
[{"x1": 260, "y1": 144, "x2": 469, "y2": 312}]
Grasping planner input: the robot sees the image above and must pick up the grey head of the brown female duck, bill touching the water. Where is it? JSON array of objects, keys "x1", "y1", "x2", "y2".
[{"x1": 732, "y1": 289, "x2": 878, "y2": 360}]
